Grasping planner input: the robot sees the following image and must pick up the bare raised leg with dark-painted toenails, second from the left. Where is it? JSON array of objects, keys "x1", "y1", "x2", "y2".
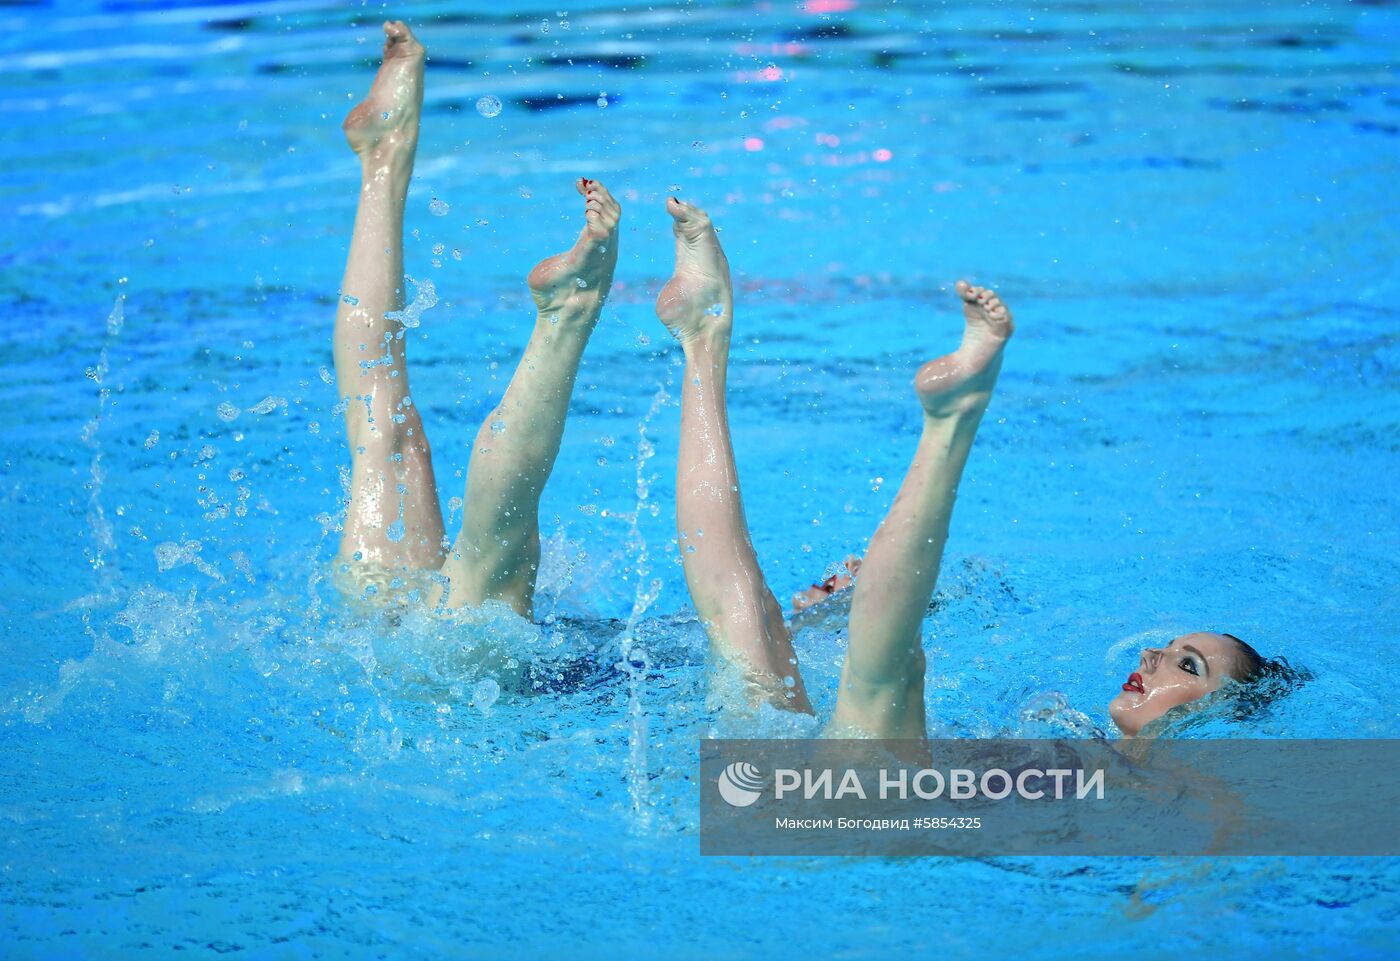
[{"x1": 442, "y1": 179, "x2": 622, "y2": 616}]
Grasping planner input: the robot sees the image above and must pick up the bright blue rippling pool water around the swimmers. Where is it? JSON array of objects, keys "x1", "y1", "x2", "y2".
[{"x1": 0, "y1": 0, "x2": 1400, "y2": 958}]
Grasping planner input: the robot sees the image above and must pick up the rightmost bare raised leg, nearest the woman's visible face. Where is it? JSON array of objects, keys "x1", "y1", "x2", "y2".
[{"x1": 832, "y1": 282, "x2": 1012, "y2": 738}]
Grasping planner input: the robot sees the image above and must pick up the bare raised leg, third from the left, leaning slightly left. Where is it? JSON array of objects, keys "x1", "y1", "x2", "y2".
[{"x1": 657, "y1": 198, "x2": 812, "y2": 712}]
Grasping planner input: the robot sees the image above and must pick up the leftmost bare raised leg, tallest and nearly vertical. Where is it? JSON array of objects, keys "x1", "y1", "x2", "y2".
[{"x1": 335, "y1": 21, "x2": 442, "y2": 570}]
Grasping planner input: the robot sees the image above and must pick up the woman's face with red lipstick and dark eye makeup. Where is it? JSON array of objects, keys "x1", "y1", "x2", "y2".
[{"x1": 1109, "y1": 632, "x2": 1240, "y2": 737}]
